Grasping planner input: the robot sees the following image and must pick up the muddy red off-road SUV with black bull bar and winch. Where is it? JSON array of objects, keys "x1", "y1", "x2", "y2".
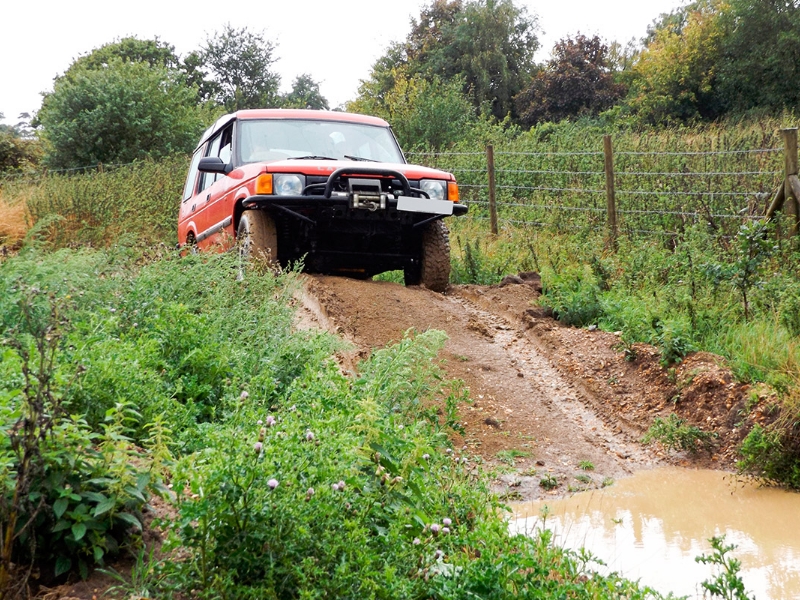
[{"x1": 178, "y1": 109, "x2": 467, "y2": 291}]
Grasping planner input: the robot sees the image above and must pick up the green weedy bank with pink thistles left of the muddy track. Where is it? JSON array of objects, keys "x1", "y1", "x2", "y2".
[{"x1": 0, "y1": 247, "x2": 668, "y2": 599}]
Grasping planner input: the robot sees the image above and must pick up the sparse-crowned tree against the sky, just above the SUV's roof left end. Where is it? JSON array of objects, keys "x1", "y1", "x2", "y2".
[{"x1": 199, "y1": 24, "x2": 280, "y2": 111}]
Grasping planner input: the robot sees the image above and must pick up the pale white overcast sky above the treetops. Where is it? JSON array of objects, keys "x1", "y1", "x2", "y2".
[{"x1": 0, "y1": 0, "x2": 683, "y2": 123}]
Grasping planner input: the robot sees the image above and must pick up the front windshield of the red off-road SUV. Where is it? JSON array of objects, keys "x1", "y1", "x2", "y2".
[{"x1": 237, "y1": 119, "x2": 405, "y2": 163}]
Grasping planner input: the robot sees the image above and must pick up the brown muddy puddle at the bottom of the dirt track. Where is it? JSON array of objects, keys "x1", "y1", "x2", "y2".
[{"x1": 510, "y1": 468, "x2": 800, "y2": 600}]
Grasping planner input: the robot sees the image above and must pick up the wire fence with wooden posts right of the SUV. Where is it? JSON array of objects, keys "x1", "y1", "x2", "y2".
[{"x1": 408, "y1": 139, "x2": 784, "y2": 243}]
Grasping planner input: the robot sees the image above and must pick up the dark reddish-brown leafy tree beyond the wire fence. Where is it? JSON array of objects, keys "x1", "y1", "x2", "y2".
[{"x1": 514, "y1": 34, "x2": 625, "y2": 125}]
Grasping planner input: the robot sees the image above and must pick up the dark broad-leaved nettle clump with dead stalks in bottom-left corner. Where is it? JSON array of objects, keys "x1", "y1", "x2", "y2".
[{"x1": 0, "y1": 284, "x2": 164, "y2": 597}]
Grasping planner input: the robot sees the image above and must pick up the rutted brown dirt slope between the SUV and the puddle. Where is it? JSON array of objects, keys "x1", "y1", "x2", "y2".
[{"x1": 299, "y1": 274, "x2": 760, "y2": 500}]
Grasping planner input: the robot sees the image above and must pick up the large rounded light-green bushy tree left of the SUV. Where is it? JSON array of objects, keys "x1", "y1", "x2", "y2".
[{"x1": 37, "y1": 59, "x2": 204, "y2": 168}]
